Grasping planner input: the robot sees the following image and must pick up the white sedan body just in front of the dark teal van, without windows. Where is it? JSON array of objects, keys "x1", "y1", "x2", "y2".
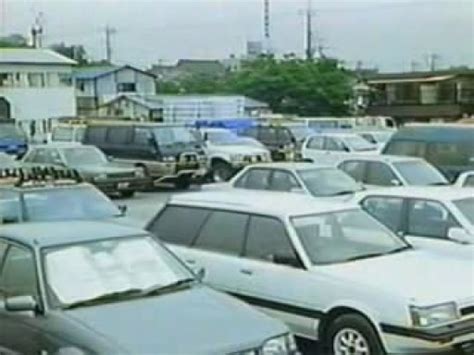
[{"x1": 334, "y1": 154, "x2": 448, "y2": 188}]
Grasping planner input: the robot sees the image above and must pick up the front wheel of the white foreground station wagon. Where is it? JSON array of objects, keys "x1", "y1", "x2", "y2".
[{"x1": 323, "y1": 314, "x2": 385, "y2": 355}]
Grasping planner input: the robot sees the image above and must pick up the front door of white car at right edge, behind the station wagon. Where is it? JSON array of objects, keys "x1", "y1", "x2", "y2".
[{"x1": 405, "y1": 199, "x2": 463, "y2": 255}]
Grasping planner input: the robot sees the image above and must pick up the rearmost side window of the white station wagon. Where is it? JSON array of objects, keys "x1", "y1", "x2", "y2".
[{"x1": 148, "y1": 206, "x2": 210, "y2": 245}]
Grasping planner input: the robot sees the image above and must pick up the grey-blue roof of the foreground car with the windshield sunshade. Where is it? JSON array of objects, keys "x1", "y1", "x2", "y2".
[{"x1": 0, "y1": 221, "x2": 146, "y2": 248}]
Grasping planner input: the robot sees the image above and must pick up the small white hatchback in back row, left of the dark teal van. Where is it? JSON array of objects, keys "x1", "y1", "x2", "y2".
[{"x1": 301, "y1": 133, "x2": 378, "y2": 165}]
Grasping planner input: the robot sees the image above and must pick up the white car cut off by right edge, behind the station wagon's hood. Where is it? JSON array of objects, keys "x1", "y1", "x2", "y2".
[{"x1": 357, "y1": 186, "x2": 474, "y2": 258}]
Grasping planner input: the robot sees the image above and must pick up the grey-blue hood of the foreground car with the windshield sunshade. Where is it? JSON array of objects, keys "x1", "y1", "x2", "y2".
[{"x1": 66, "y1": 286, "x2": 287, "y2": 355}]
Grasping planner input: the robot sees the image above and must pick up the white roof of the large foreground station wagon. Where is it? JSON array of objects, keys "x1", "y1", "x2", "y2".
[{"x1": 168, "y1": 189, "x2": 357, "y2": 218}]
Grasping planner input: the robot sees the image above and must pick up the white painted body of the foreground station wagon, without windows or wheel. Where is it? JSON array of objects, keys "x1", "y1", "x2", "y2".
[{"x1": 148, "y1": 190, "x2": 474, "y2": 355}]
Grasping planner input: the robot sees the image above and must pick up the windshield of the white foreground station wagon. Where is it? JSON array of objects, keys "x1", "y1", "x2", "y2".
[{"x1": 292, "y1": 210, "x2": 407, "y2": 265}]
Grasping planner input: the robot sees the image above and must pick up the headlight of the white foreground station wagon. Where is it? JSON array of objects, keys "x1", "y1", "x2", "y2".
[{"x1": 410, "y1": 302, "x2": 459, "y2": 327}]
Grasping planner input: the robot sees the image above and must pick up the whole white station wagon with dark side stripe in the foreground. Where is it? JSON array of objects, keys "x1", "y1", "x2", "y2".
[{"x1": 148, "y1": 189, "x2": 474, "y2": 355}]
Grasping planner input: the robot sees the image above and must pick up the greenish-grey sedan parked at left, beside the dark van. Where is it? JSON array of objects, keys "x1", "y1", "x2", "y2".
[{"x1": 23, "y1": 143, "x2": 147, "y2": 197}]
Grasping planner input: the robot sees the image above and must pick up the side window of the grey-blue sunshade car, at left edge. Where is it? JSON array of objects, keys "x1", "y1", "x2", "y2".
[{"x1": 0, "y1": 246, "x2": 37, "y2": 297}]
